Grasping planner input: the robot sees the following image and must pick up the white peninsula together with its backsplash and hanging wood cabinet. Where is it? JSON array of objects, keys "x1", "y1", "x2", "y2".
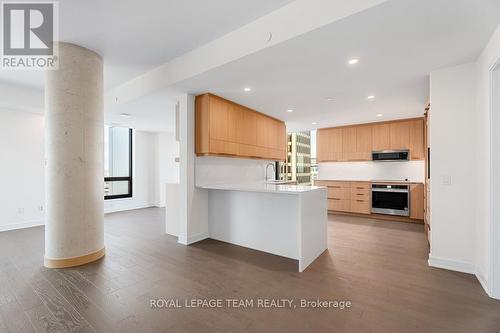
[{"x1": 195, "y1": 94, "x2": 328, "y2": 272}]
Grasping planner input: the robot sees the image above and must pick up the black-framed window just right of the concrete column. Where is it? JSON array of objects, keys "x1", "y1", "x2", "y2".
[{"x1": 104, "y1": 126, "x2": 132, "y2": 200}]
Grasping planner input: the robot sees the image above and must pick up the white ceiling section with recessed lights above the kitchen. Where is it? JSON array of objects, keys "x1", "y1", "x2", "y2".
[{"x1": 176, "y1": 0, "x2": 500, "y2": 130}]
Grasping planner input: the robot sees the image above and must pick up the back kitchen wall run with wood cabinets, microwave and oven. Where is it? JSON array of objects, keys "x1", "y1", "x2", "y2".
[{"x1": 315, "y1": 115, "x2": 429, "y2": 230}]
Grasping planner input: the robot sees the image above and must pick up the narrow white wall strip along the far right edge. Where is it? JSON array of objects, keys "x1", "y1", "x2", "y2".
[{"x1": 475, "y1": 26, "x2": 500, "y2": 297}]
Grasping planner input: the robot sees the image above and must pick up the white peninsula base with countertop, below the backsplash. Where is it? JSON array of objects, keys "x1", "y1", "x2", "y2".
[{"x1": 200, "y1": 183, "x2": 328, "y2": 272}]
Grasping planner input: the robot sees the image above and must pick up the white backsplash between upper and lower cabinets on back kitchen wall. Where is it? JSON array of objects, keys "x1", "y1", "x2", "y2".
[{"x1": 318, "y1": 161, "x2": 425, "y2": 183}]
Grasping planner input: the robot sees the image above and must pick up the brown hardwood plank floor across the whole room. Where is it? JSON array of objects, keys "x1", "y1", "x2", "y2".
[{"x1": 0, "y1": 208, "x2": 500, "y2": 333}]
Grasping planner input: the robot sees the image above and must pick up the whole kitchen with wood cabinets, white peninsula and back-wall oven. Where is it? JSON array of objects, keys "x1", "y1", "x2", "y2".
[{"x1": 179, "y1": 93, "x2": 426, "y2": 272}]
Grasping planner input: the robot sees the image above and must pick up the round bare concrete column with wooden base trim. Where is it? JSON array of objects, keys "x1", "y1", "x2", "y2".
[{"x1": 45, "y1": 43, "x2": 105, "y2": 268}]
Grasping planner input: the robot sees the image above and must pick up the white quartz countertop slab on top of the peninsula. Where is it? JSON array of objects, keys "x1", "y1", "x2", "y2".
[{"x1": 198, "y1": 183, "x2": 324, "y2": 194}]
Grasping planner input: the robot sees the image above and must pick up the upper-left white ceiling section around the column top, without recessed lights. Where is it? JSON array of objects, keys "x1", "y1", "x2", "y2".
[{"x1": 0, "y1": 0, "x2": 291, "y2": 88}]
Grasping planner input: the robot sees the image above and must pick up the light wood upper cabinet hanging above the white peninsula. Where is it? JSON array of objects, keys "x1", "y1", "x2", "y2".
[{"x1": 195, "y1": 94, "x2": 286, "y2": 160}]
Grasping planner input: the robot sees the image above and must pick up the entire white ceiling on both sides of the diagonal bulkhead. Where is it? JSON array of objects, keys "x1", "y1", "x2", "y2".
[{"x1": 0, "y1": 0, "x2": 500, "y2": 131}]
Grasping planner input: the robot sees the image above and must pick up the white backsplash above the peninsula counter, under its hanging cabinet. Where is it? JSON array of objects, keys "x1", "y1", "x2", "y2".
[{"x1": 195, "y1": 156, "x2": 274, "y2": 186}]
